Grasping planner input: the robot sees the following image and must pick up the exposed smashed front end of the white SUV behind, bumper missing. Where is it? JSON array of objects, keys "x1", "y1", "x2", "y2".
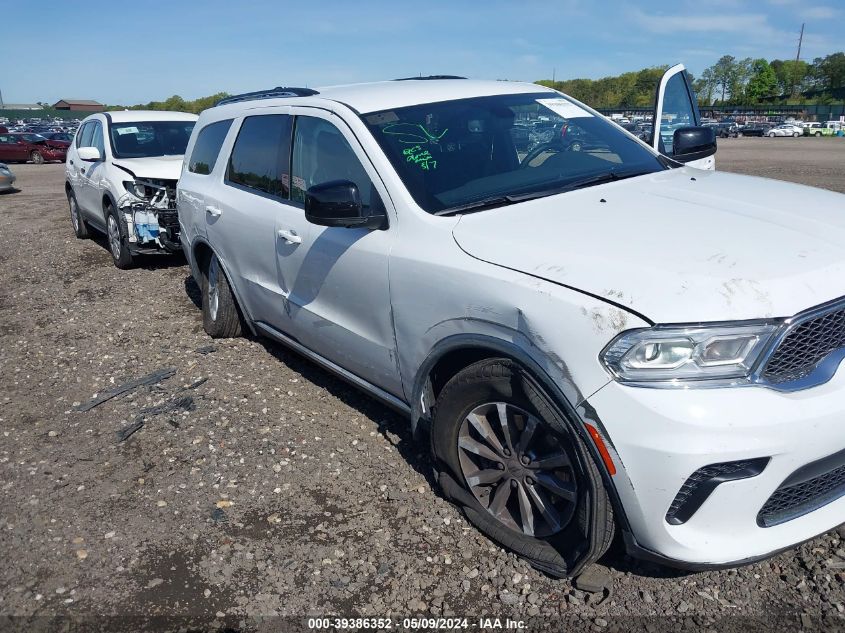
[{"x1": 117, "y1": 178, "x2": 182, "y2": 252}]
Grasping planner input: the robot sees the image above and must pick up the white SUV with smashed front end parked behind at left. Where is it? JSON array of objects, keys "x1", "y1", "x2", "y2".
[{"x1": 65, "y1": 110, "x2": 197, "y2": 268}]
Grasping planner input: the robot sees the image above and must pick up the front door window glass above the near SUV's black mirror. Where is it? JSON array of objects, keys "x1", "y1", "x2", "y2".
[{"x1": 291, "y1": 116, "x2": 373, "y2": 207}]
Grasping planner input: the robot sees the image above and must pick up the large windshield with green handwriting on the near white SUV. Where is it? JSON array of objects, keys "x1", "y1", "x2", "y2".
[{"x1": 362, "y1": 92, "x2": 666, "y2": 213}]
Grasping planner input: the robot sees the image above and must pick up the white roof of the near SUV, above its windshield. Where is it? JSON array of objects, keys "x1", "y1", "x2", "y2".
[{"x1": 211, "y1": 79, "x2": 557, "y2": 114}]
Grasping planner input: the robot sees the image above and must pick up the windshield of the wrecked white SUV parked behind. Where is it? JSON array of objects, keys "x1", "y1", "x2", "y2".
[{"x1": 109, "y1": 121, "x2": 194, "y2": 158}]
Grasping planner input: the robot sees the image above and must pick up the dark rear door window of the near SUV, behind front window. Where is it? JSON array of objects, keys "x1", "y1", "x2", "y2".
[{"x1": 226, "y1": 114, "x2": 291, "y2": 199}]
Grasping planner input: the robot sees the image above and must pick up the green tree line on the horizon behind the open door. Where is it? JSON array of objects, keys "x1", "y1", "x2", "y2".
[{"x1": 536, "y1": 52, "x2": 845, "y2": 108}]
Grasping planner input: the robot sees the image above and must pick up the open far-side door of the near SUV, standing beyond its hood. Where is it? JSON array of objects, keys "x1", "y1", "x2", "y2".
[{"x1": 652, "y1": 64, "x2": 716, "y2": 169}]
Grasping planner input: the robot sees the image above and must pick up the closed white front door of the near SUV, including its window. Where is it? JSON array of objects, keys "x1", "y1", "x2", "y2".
[{"x1": 284, "y1": 108, "x2": 402, "y2": 397}]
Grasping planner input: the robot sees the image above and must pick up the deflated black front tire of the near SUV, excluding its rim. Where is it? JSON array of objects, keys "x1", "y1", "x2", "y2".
[{"x1": 431, "y1": 359, "x2": 615, "y2": 577}]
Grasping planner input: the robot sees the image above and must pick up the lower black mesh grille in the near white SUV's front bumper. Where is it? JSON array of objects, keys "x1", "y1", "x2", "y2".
[{"x1": 757, "y1": 454, "x2": 845, "y2": 527}]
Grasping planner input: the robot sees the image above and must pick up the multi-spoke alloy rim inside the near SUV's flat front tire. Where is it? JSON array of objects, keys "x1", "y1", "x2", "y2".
[{"x1": 458, "y1": 402, "x2": 578, "y2": 538}]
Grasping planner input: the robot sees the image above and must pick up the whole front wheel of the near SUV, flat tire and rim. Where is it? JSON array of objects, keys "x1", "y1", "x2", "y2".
[{"x1": 431, "y1": 359, "x2": 614, "y2": 577}]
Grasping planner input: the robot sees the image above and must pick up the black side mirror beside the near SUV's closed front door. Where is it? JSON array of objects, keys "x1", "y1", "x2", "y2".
[{"x1": 305, "y1": 180, "x2": 387, "y2": 229}]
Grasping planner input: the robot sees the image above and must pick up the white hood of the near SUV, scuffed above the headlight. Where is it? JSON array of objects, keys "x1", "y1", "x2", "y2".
[{"x1": 453, "y1": 168, "x2": 845, "y2": 323}]
